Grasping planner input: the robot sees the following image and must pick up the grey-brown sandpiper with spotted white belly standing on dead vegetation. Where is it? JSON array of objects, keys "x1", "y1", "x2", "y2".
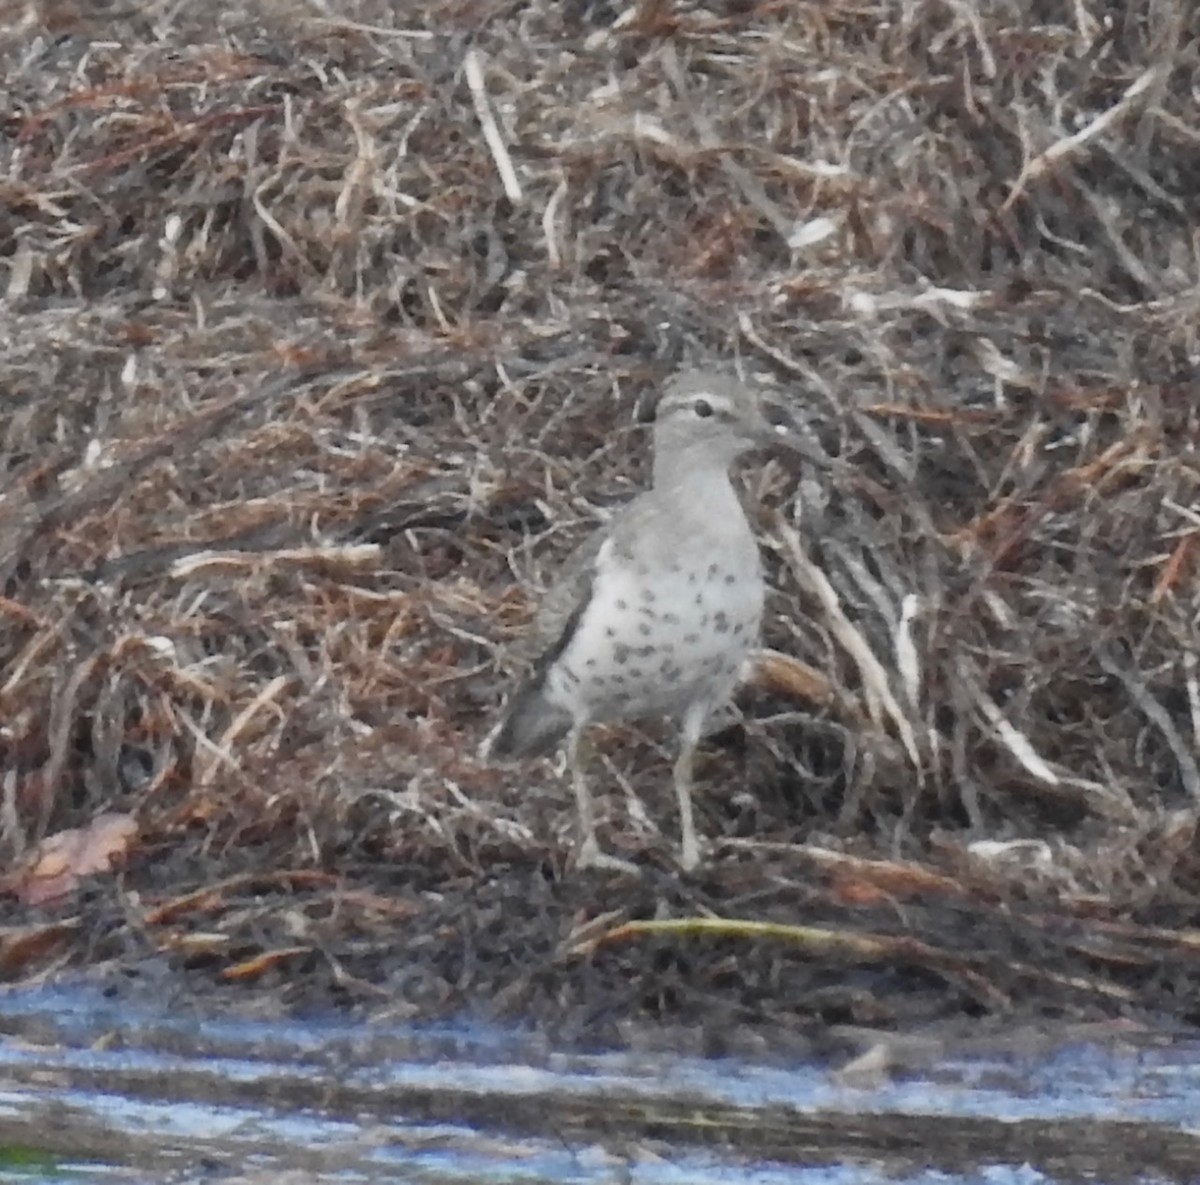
[{"x1": 481, "y1": 367, "x2": 796, "y2": 872}]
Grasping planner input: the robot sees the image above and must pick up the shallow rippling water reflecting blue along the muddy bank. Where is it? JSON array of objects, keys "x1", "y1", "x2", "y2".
[{"x1": 0, "y1": 987, "x2": 1200, "y2": 1185}]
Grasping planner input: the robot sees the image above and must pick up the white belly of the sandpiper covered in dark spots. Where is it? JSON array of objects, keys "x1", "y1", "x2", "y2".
[{"x1": 547, "y1": 552, "x2": 762, "y2": 721}]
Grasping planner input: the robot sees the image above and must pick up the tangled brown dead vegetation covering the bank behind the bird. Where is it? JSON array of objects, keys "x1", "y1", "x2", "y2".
[{"x1": 0, "y1": 0, "x2": 1200, "y2": 1036}]
